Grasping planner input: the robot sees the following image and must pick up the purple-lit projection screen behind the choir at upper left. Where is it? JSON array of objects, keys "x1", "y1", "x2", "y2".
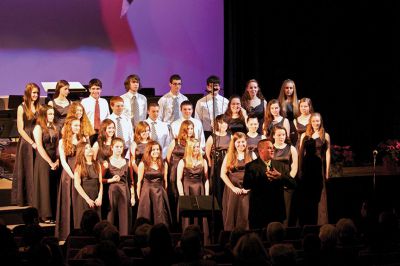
[{"x1": 0, "y1": 0, "x2": 224, "y2": 95}]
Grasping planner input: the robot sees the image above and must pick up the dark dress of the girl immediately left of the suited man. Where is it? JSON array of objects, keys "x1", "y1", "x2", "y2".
[{"x1": 222, "y1": 159, "x2": 249, "y2": 231}]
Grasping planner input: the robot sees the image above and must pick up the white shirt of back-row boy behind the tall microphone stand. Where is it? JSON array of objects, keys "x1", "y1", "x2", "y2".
[{"x1": 194, "y1": 94, "x2": 229, "y2": 131}]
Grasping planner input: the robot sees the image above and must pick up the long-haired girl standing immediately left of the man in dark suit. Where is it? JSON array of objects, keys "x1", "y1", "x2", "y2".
[{"x1": 221, "y1": 132, "x2": 256, "y2": 231}]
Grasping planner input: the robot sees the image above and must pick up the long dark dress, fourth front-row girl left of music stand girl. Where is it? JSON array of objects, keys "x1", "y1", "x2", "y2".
[{"x1": 55, "y1": 145, "x2": 78, "y2": 241}]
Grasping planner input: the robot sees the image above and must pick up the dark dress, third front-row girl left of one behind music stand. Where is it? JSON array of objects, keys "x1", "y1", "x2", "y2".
[{"x1": 74, "y1": 164, "x2": 101, "y2": 229}]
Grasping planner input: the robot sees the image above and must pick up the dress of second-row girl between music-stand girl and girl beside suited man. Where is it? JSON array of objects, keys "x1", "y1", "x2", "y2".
[{"x1": 210, "y1": 134, "x2": 231, "y2": 208}]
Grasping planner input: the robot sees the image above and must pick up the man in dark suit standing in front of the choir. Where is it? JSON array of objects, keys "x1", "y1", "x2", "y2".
[{"x1": 243, "y1": 139, "x2": 296, "y2": 229}]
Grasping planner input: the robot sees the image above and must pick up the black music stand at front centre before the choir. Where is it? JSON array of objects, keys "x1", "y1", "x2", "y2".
[{"x1": 178, "y1": 195, "x2": 221, "y2": 218}]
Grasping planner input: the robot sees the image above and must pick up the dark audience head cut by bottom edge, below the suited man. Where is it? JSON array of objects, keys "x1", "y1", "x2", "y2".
[{"x1": 269, "y1": 244, "x2": 296, "y2": 266}]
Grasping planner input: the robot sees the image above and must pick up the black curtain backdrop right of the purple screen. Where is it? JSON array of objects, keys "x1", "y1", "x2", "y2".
[{"x1": 224, "y1": 0, "x2": 400, "y2": 164}]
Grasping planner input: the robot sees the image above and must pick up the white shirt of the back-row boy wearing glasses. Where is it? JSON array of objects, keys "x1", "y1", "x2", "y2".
[{"x1": 158, "y1": 92, "x2": 188, "y2": 124}]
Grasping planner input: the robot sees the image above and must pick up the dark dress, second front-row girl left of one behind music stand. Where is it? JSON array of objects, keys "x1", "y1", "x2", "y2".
[{"x1": 107, "y1": 161, "x2": 132, "y2": 235}]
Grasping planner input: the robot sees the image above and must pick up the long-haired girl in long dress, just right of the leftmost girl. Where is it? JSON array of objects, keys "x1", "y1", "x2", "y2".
[{"x1": 33, "y1": 105, "x2": 59, "y2": 222}]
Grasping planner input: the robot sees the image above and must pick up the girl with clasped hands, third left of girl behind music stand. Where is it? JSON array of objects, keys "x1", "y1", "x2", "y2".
[{"x1": 74, "y1": 142, "x2": 103, "y2": 229}]
